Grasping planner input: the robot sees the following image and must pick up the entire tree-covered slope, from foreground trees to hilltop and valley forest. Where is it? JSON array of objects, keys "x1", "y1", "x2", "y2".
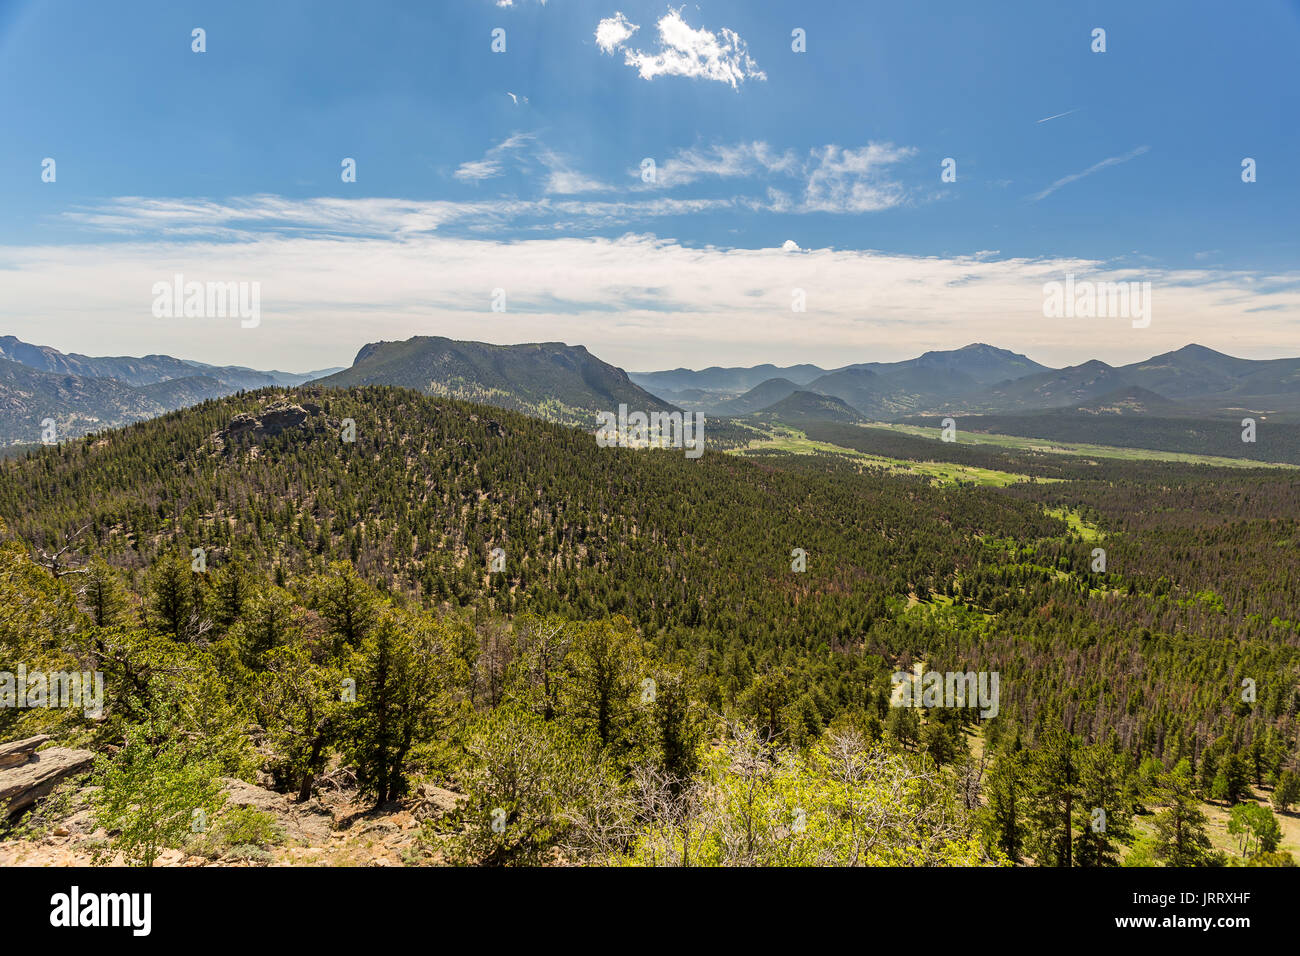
[{"x1": 0, "y1": 386, "x2": 1300, "y2": 865}]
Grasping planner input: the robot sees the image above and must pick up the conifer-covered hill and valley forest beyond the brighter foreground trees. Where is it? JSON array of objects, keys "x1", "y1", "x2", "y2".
[{"x1": 0, "y1": 386, "x2": 1300, "y2": 758}]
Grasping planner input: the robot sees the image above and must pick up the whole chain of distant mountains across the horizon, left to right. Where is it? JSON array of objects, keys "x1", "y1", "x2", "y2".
[{"x1": 0, "y1": 336, "x2": 1300, "y2": 445}]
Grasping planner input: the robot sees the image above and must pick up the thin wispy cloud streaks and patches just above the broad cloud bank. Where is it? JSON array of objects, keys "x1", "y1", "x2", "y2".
[{"x1": 60, "y1": 141, "x2": 915, "y2": 241}]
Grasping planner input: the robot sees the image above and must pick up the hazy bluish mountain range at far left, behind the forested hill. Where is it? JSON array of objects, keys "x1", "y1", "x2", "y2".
[{"x1": 0, "y1": 336, "x2": 337, "y2": 445}]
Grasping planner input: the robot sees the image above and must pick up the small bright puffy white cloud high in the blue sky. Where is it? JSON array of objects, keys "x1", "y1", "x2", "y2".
[{"x1": 595, "y1": 10, "x2": 767, "y2": 90}]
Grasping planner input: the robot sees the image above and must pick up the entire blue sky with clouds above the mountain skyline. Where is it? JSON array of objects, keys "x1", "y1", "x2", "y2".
[{"x1": 0, "y1": 0, "x2": 1300, "y2": 369}]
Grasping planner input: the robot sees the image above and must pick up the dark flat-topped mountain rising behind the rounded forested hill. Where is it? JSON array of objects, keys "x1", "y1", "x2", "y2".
[{"x1": 316, "y1": 336, "x2": 676, "y2": 428}]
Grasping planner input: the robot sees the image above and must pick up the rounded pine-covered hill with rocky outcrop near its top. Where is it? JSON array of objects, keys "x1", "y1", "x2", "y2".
[{"x1": 0, "y1": 388, "x2": 1062, "y2": 646}]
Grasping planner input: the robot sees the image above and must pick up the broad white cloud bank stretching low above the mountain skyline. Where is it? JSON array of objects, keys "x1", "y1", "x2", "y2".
[{"x1": 10, "y1": 196, "x2": 1300, "y2": 369}]
